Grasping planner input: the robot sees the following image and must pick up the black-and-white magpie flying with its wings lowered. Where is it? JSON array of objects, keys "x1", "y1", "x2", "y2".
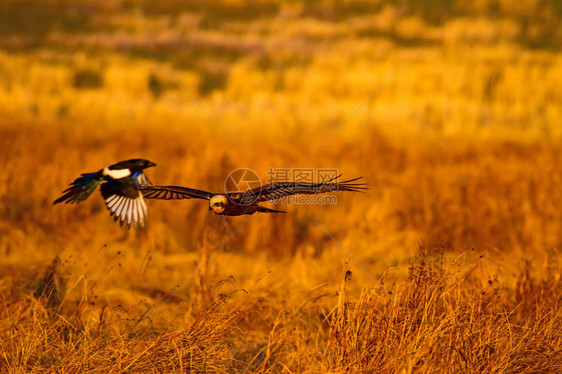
[{"x1": 53, "y1": 158, "x2": 156, "y2": 228}]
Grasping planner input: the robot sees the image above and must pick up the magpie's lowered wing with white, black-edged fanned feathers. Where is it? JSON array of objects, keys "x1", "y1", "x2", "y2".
[{"x1": 100, "y1": 178, "x2": 148, "y2": 227}]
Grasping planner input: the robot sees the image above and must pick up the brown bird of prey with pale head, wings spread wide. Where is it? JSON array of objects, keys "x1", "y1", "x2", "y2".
[{"x1": 140, "y1": 175, "x2": 367, "y2": 216}]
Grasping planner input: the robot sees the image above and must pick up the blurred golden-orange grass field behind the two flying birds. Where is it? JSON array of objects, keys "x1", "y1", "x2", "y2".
[{"x1": 0, "y1": 0, "x2": 562, "y2": 372}]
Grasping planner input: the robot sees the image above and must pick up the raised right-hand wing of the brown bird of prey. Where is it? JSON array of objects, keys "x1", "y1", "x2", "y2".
[{"x1": 243, "y1": 175, "x2": 367, "y2": 202}]
